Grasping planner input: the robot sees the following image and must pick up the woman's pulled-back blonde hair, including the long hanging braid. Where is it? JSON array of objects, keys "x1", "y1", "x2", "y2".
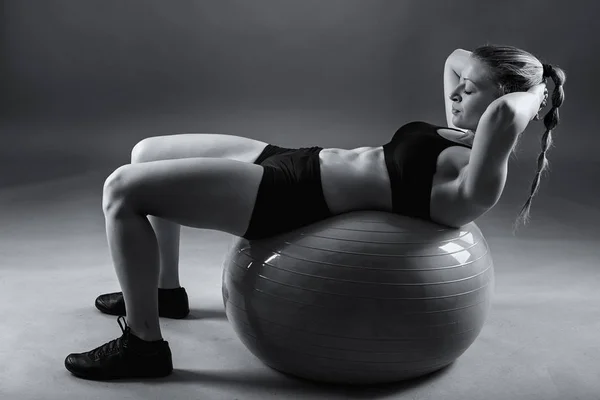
[{"x1": 472, "y1": 44, "x2": 566, "y2": 235}]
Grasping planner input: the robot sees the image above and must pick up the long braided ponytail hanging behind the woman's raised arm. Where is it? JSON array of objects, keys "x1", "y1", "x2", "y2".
[{"x1": 513, "y1": 64, "x2": 566, "y2": 235}]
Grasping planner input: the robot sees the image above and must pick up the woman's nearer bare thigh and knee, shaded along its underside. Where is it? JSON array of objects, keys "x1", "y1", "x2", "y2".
[{"x1": 102, "y1": 157, "x2": 264, "y2": 236}]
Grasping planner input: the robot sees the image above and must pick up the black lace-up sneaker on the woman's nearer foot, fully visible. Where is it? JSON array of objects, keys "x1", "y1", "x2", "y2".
[{"x1": 65, "y1": 316, "x2": 173, "y2": 380}]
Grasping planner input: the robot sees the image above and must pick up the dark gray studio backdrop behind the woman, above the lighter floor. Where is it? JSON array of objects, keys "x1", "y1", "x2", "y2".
[{"x1": 0, "y1": 0, "x2": 600, "y2": 206}]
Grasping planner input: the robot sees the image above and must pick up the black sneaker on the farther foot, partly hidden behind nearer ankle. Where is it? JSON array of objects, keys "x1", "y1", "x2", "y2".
[{"x1": 96, "y1": 287, "x2": 190, "y2": 319}]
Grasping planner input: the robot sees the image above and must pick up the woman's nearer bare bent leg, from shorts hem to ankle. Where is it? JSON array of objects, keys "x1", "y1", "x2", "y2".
[{"x1": 102, "y1": 158, "x2": 263, "y2": 341}]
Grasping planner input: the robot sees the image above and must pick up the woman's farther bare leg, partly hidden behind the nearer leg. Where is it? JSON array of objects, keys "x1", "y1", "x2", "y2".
[{"x1": 131, "y1": 133, "x2": 267, "y2": 289}]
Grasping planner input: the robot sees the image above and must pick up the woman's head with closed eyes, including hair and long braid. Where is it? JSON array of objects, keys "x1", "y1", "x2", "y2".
[{"x1": 452, "y1": 45, "x2": 566, "y2": 233}]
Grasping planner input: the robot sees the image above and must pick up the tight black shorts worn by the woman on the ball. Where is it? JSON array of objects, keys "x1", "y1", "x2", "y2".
[{"x1": 242, "y1": 144, "x2": 332, "y2": 240}]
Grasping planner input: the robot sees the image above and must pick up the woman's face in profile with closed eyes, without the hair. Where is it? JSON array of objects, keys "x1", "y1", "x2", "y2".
[{"x1": 450, "y1": 57, "x2": 501, "y2": 132}]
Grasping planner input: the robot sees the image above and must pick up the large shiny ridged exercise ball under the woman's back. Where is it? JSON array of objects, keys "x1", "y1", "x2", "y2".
[{"x1": 222, "y1": 211, "x2": 494, "y2": 384}]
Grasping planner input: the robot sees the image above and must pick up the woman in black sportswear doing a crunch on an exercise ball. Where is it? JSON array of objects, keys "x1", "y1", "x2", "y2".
[{"x1": 65, "y1": 45, "x2": 565, "y2": 379}]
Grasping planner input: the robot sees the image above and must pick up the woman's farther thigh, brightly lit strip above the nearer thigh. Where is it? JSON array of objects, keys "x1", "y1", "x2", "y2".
[{"x1": 131, "y1": 133, "x2": 267, "y2": 163}]
